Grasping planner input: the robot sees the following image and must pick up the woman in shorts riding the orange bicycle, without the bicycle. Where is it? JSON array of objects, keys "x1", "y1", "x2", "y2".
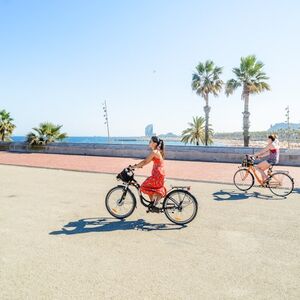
[{"x1": 254, "y1": 134, "x2": 279, "y2": 181}]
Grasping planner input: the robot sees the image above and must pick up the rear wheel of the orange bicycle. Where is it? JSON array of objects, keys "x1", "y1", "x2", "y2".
[{"x1": 268, "y1": 172, "x2": 294, "y2": 197}]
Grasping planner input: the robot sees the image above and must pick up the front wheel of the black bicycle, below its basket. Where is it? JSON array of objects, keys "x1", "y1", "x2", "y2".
[{"x1": 105, "y1": 185, "x2": 136, "y2": 219}]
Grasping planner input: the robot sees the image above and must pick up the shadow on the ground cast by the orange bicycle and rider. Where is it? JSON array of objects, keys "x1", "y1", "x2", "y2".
[{"x1": 213, "y1": 189, "x2": 286, "y2": 201}]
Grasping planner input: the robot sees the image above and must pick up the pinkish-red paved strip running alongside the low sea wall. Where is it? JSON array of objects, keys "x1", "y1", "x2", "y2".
[{"x1": 0, "y1": 152, "x2": 300, "y2": 187}]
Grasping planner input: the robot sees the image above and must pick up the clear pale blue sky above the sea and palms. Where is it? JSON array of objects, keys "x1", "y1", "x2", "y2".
[{"x1": 0, "y1": 0, "x2": 300, "y2": 136}]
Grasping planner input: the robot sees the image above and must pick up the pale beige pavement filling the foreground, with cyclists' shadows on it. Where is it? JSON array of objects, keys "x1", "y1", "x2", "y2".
[{"x1": 0, "y1": 165, "x2": 300, "y2": 300}]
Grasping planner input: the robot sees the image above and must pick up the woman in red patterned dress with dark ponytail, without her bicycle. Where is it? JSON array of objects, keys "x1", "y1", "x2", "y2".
[{"x1": 133, "y1": 136, "x2": 166, "y2": 204}]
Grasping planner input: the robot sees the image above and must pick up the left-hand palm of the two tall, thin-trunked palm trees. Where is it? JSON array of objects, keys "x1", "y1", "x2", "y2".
[{"x1": 192, "y1": 60, "x2": 224, "y2": 146}]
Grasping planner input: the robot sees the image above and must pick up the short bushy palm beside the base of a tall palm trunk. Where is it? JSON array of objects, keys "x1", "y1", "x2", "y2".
[{"x1": 181, "y1": 117, "x2": 213, "y2": 146}]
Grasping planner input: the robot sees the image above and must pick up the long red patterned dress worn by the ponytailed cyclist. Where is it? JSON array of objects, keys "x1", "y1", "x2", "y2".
[{"x1": 141, "y1": 157, "x2": 167, "y2": 197}]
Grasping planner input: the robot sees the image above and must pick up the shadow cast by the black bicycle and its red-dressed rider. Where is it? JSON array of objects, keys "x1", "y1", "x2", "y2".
[{"x1": 49, "y1": 218, "x2": 186, "y2": 235}]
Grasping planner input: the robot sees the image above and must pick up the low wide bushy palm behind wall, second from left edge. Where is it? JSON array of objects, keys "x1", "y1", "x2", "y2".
[{"x1": 27, "y1": 122, "x2": 67, "y2": 145}]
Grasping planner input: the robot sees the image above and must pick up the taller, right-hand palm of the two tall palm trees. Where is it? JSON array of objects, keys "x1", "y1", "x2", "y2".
[{"x1": 225, "y1": 55, "x2": 270, "y2": 147}]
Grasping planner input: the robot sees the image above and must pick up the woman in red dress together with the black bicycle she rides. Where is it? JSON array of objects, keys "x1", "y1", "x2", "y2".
[{"x1": 105, "y1": 136, "x2": 198, "y2": 225}]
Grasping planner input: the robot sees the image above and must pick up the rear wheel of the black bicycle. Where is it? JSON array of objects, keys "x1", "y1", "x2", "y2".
[{"x1": 163, "y1": 190, "x2": 198, "y2": 225}]
